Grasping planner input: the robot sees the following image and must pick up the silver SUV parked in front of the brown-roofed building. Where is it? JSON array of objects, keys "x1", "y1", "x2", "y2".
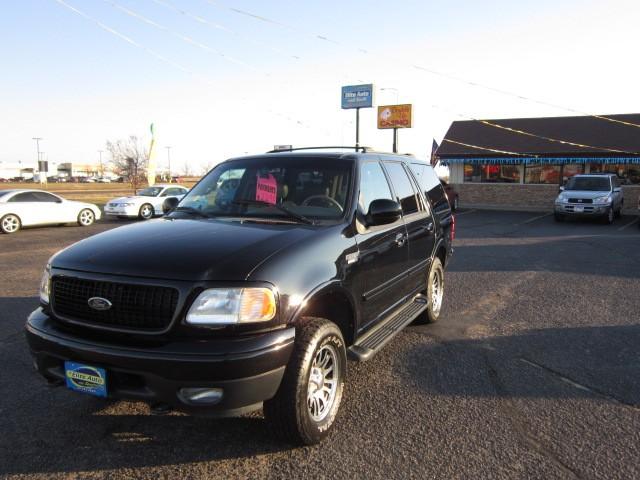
[{"x1": 554, "y1": 173, "x2": 624, "y2": 223}]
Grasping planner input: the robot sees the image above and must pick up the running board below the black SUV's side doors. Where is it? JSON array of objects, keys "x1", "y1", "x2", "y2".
[{"x1": 348, "y1": 295, "x2": 429, "y2": 362}]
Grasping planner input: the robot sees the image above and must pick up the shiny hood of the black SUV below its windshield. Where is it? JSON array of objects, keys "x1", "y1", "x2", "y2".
[{"x1": 52, "y1": 218, "x2": 314, "y2": 281}]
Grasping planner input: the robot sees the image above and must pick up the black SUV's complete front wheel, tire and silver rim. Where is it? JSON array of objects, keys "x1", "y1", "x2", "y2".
[{"x1": 264, "y1": 317, "x2": 347, "y2": 445}]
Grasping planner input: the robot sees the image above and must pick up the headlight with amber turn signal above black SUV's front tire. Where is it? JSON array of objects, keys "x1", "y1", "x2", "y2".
[{"x1": 187, "y1": 288, "x2": 276, "y2": 325}]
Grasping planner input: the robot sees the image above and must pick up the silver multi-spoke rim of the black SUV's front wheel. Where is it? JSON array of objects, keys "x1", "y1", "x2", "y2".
[{"x1": 307, "y1": 345, "x2": 340, "y2": 422}]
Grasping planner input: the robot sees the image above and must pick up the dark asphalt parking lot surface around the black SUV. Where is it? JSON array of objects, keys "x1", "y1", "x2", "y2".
[{"x1": 0, "y1": 210, "x2": 640, "y2": 479}]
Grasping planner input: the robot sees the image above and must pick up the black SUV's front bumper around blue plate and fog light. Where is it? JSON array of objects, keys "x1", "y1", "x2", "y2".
[{"x1": 25, "y1": 308, "x2": 295, "y2": 416}]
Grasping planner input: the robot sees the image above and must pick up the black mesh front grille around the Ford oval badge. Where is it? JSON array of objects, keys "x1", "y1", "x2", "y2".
[{"x1": 52, "y1": 277, "x2": 178, "y2": 330}]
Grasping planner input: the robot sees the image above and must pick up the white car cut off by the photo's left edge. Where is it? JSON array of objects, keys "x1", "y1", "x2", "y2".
[{"x1": 0, "y1": 190, "x2": 102, "y2": 233}]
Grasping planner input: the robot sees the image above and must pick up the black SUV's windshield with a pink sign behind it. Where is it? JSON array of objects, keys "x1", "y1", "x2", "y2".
[{"x1": 178, "y1": 155, "x2": 353, "y2": 223}]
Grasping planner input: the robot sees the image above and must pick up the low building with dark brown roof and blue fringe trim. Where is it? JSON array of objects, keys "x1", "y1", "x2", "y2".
[{"x1": 436, "y1": 114, "x2": 640, "y2": 211}]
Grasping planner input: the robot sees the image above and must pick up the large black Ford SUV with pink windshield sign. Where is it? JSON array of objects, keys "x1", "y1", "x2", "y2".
[{"x1": 26, "y1": 150, "x2": 454, "y2": 444}]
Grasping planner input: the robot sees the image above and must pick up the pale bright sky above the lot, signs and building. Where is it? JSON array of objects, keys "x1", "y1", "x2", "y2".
[{"x1": 0, "y1": 0, "x2": 640, "y2": 173}]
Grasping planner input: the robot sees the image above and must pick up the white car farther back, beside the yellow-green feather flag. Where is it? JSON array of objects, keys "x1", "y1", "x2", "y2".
[{"x1": 104, "y1": 184, "x2": 189, "y2": 220}]
